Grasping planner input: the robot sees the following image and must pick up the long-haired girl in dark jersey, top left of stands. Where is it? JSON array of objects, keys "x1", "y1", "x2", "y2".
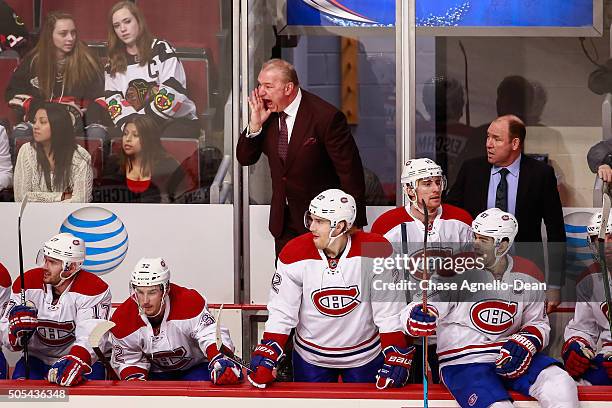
[{"x1": 5, "y1": 12, "x2": 110, "y2": 138}]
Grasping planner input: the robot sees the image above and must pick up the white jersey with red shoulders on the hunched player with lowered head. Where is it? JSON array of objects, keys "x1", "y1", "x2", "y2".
[{"x1": 111, "y1": 284, "x2": 234, "y2": 380}]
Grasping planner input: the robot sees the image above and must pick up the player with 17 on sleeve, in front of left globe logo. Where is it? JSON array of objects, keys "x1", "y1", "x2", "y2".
[{"x1": 0, "y1": 233, "x2": 111, "y2": 386}]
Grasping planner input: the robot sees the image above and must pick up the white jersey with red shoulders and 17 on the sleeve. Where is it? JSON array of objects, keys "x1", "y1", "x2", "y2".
[{"x1": 0, "y1": 268, "x2": 111, "y2": 365}]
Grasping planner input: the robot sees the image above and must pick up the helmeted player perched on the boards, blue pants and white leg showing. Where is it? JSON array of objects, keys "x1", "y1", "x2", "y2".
[{"x1": 401, "y1": 208, "x2": 579, "y2": 408}]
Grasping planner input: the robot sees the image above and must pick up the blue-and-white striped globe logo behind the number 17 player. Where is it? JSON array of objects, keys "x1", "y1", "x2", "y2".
[{"x1": 60, "y1": 207, "x2": 128, "y2": 275}]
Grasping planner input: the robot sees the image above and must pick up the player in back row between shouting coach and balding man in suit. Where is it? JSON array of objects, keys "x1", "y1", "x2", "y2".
[{"x1": 372, "y1": 158, "x2": 472, "y2": 383}]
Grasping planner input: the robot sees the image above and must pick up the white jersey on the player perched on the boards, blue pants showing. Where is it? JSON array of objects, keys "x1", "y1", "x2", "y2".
[{"x1": 401, "y1": 256, "x2": 550, "y2": 367}]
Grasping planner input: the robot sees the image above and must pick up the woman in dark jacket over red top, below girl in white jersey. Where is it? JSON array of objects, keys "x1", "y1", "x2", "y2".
[{"x1": 94, "y1": 115, "x2": 187, "y2": 203}]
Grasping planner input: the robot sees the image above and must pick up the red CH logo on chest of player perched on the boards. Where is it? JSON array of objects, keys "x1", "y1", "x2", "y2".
[{"x1": 470, "y1": 299, "x2": 518, "y2": 334}]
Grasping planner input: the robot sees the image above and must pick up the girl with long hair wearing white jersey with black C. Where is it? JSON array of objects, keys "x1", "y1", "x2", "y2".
[{"x1": 105, "y1": 1, "x2": 200, "y2": 138}]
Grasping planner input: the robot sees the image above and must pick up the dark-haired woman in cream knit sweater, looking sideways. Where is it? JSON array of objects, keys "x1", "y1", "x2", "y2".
[{"x1": 14, "y1": 103, "x2": 93, "y2": 203}]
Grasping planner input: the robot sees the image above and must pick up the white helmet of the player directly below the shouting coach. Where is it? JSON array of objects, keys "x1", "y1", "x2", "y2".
[{"x1": 304, "y1": 188, "x2": 357, "y2": 230}]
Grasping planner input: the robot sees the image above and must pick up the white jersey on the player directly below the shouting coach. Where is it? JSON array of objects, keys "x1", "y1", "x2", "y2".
[{"x1": 265, "y1": 231, "x2": 406, "y2": 368}]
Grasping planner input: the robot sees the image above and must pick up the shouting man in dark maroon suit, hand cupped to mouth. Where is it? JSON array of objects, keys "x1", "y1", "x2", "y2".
[{"x1": 236, "y1": 59, "x2": 367, "y2": 255}]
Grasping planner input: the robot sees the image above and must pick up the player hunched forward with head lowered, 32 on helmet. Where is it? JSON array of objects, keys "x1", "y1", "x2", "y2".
[{"x1": 111, "y1": 258, "x2": 243, "y2": 385}]
